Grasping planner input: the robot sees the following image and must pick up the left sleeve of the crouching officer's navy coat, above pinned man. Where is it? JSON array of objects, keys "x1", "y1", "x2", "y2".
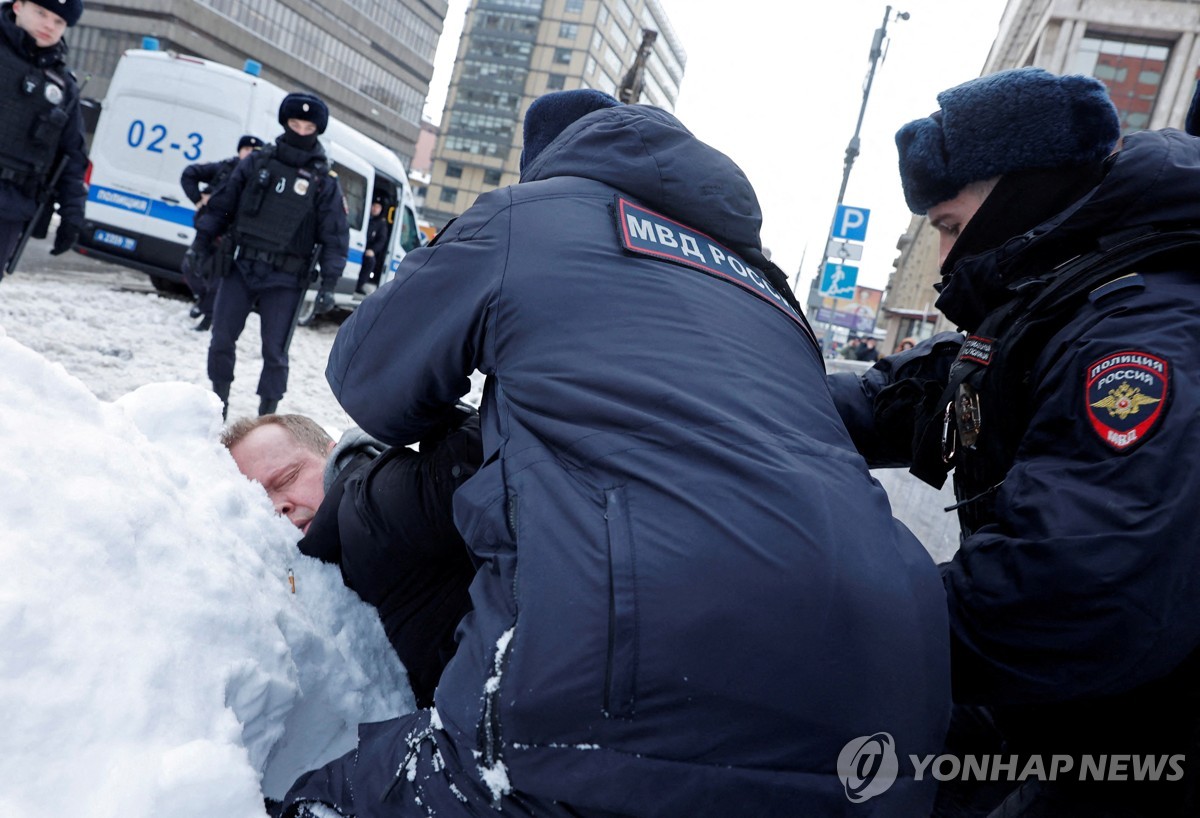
[{"x1": 325, "y1": 188, "x2": 511, "y2": 445}]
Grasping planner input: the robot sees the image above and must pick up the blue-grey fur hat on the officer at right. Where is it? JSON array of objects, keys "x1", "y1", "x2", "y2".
[{"x1": 896, "y1": 68, "x2": 1121, "y2": 213}]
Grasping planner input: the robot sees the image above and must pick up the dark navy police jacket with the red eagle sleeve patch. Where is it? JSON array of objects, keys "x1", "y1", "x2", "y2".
[{"x1": 830, "y1": 130, "x2": 1200, "y2": 753}]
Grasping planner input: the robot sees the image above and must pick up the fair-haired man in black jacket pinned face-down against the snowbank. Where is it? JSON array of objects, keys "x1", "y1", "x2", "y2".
[{"x1": 221, "y1": 408, "x2": 482, "y2": 708}]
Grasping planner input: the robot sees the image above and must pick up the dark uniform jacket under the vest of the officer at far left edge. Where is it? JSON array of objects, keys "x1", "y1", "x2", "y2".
[{"x1": 0, "y1": 2, "x2": 88, "y2": 227}]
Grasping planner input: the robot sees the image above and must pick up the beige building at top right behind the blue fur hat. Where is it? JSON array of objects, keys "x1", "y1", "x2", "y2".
[{"x1": 883, "y1": 0, "x2": 1200, "y2": 350}]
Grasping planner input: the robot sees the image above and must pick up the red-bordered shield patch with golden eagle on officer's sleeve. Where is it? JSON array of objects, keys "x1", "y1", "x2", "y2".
[{"x1": 1084, "y1": 349, "x2": 1170, "y2": 452}]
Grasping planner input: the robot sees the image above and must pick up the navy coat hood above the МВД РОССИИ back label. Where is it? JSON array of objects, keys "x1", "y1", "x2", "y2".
[{"x1": 521, "y1": 106, "x2": 769, "y2": 266}]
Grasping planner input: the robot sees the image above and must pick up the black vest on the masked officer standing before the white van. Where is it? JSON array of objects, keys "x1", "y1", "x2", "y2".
[{"x1": 234, "y1": 149, "x2": 328, "y2": 261}]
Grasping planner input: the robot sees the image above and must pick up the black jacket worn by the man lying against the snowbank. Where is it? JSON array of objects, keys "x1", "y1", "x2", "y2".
[{"x1": 300, "y1": 415, "x2": 482, "y2": 708}]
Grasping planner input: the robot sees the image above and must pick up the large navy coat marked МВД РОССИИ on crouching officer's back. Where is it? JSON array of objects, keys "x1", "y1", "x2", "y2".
[{"x1": 316, "y1": 106, "x2": 949, "y2": 816}]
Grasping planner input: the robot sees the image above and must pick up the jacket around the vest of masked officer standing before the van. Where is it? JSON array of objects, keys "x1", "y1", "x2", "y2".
[{"x1": 196, "y1": 138, "x2": 350, "y2": 289}]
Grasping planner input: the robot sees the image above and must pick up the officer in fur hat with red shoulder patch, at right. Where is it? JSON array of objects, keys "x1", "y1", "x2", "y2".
[{"x1": 830, "y1": 68, "x2": 1200, "y2": 818}]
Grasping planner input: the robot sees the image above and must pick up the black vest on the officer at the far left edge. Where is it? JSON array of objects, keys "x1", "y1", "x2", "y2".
[{"x1": 0, "y1": 46, "x2": 71, "y2": 196}]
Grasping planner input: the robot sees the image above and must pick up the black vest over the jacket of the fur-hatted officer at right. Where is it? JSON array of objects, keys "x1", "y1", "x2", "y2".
[{"x1": 913, "y1": 230, "x2": 1200, "y2": 536}]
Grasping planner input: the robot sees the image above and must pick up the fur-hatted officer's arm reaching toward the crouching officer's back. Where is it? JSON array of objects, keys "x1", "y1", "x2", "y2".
[{"x1": 827, "y1": 332, "x2": 962, "y2": 468}]
